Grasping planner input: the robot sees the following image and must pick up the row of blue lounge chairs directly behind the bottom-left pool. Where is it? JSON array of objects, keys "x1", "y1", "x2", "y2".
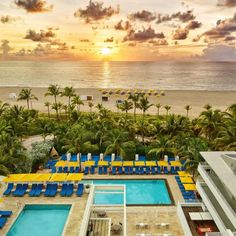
[{"x1": 3, "y1": 183, "x2": 84, "y2": 197}]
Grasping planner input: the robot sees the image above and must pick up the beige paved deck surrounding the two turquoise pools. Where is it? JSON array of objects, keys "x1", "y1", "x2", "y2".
[{"x1": 0, "y1": 174, "x2": 184, "y2": 236}]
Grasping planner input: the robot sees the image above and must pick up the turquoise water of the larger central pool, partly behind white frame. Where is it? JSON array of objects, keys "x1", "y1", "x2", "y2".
[{"x1": 87, "y1": 180, "x2": 172, "y2": 205}]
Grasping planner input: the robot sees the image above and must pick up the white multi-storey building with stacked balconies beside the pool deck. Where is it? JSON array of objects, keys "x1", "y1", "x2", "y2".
[{"x1": 178, "y1": 152, "x2": 236, "y2": 236}]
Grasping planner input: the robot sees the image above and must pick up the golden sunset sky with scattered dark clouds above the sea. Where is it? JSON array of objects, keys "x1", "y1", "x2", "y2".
[{"x1": 0, "y1": 0, "x2": 236, "y2": 61}]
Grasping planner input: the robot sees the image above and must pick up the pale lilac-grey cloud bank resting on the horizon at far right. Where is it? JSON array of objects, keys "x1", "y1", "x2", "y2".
[{"x1": 200, "y1": 45, "x2": 236, "y2": 61}]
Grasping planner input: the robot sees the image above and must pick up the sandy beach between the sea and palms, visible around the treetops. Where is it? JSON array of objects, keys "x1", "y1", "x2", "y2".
[{"x1": 0, "y1": 87, "x2": 236, "y2": 117}]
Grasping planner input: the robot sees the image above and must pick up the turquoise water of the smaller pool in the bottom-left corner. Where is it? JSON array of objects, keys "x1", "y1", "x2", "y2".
[{"x1": 7, "y1": 205, "x2": 71, "y2": 236}]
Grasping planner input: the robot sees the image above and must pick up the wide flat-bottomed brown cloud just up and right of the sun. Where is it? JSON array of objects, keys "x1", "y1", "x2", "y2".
[{"x1": 124, "y1": 26, "x2": 165, "y2": 41}]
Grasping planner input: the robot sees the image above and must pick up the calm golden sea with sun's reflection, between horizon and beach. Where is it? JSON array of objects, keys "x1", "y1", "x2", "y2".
[{"x1": 0, "y1": 61, "x2": 236, "y2": 91}]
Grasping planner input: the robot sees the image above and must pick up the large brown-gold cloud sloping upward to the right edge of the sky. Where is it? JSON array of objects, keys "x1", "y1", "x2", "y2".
[{"x1": 203, "y1": 13, "x2": 236, "y2": 39}]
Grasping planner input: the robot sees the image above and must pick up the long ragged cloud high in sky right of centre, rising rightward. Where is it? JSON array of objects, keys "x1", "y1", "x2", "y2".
[{"x1": 156, "y1": 10, "x2": 196, "y2": 24}]
